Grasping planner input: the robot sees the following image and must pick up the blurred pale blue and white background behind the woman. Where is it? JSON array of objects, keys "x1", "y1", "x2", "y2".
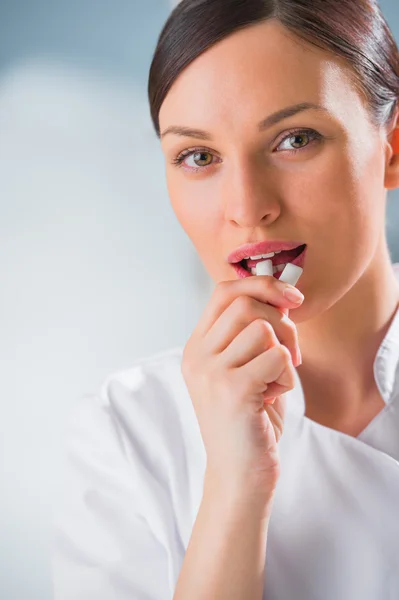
[{"x1": 0, "y1": 0, "x2": 399, "y2": 600}]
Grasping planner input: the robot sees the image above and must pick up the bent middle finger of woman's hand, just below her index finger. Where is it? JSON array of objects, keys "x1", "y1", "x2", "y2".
[{"x1": 204, "y1": 296, "x2": 299, "y2": 365}]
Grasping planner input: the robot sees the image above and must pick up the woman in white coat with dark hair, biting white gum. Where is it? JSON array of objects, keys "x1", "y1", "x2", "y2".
[{"x1": 54, "y1": 0, "x2": 399, "y2": 600}]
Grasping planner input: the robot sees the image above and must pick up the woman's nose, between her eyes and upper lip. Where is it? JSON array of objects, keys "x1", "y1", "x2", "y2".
[{"x1": 221, "y1": 163, "x2": 281, "y2": 228}]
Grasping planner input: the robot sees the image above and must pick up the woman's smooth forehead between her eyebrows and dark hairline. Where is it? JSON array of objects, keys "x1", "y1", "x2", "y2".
[{"x1": 159, "y1": 20, "x2": 364, "y2": 136}]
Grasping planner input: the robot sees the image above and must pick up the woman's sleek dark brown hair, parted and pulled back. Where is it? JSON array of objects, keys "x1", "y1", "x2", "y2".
[{"x1": 148, "y1": 0, "x2": 399, "y2": 137}]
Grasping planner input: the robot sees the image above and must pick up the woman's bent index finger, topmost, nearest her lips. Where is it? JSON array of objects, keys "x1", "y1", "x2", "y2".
[{"x1": 193, "y1": 275, "x2": 302, "y2": 337}]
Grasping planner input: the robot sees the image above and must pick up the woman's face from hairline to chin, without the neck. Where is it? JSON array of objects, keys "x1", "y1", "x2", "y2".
[{"x1": 160, "y1": 21, "x2": 396, "y2": 322}]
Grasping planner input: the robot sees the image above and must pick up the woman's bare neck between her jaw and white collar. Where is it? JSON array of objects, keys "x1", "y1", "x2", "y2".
[{"x1": 297, "y1": 240, "x2": 399, "y2": 428}]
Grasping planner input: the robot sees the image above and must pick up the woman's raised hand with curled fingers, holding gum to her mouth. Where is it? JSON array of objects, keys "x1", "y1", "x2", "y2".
[{"x1": 182, "y1": 276, "x2": 303, "y2": 498}]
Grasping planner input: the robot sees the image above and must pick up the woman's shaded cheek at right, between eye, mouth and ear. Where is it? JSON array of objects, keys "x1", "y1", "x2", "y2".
[{"x1": 284, "y1": 148, "x2": 384, "y2": 293}]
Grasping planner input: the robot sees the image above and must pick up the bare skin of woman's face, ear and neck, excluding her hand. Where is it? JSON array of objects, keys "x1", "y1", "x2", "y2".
[{"x1": 160, "y1": 21, "x2": 399, "y2": 435}]
